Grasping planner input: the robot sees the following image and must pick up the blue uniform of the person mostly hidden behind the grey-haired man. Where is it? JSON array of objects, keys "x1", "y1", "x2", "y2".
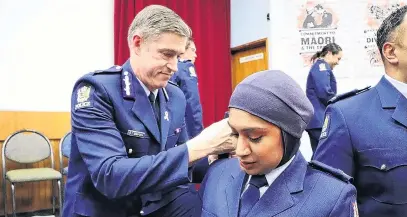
[{"x1": 171, "y1": 60, "x2": 203, "y2": 139}]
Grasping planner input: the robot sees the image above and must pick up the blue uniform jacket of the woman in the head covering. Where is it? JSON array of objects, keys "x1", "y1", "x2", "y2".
[{"x1": 200, "y1": 152, "x2": 357, "y2": 217}]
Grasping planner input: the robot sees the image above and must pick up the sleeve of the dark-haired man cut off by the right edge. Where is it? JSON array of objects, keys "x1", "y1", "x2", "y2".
[{"x1": 313, "y1": 104, "x2": 355, "y2": 177}]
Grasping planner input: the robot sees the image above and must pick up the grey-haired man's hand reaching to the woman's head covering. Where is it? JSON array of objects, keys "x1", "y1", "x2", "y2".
[{"x1": 187, "y1": 119, "x2": 237, "y2": 163}]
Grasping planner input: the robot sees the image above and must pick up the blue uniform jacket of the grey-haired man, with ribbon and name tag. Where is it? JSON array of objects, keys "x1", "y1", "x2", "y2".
[{"x1": 63, "y1": 62, "x2": 200, "y2": 217}]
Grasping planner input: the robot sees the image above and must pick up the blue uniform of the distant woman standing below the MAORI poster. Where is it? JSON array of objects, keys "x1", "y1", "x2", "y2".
[{"x1": 306, "y1": 59, "x2": 337, "y2": 152}]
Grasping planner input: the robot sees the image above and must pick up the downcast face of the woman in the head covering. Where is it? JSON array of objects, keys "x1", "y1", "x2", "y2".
[{"x1": 229, "y1": 108, "x2": 284, "y2": 175}]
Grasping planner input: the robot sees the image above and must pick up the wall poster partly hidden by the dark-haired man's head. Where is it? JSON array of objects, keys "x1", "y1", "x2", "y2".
[{"x1": 363, "y1": 0, "x2": 405, "y2": 67}]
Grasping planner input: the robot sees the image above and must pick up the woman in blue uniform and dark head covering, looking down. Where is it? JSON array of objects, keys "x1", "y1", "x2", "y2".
[{"x1": 200, "y1": 71, "x2": 357, "y2": 217}]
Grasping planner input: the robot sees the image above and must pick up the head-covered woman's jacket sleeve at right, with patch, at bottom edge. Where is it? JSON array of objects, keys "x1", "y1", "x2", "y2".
[{"x1": 329, "y1": 184, "x2": 359, "y2": 217}]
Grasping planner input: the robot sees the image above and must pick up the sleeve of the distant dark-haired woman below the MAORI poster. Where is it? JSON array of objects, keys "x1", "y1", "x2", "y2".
[{"x1": 311, "y1": 63, "x2": 336, "y2": 105}]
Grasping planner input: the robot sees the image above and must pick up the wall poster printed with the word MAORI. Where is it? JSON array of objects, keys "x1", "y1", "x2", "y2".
[{"x1": 297, "y1": 1, "x2": 339, "y2": 66}]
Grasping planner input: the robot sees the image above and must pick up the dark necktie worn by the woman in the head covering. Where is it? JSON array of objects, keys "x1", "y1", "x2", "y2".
[{"x1": 239, "y1": 175, "x2": 268, "y2": 217}]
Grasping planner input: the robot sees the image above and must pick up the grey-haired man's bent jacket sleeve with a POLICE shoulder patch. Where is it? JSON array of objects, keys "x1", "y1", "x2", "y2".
[{"x1": 71, "y1": 78, "x2": 189, "y2": 199}]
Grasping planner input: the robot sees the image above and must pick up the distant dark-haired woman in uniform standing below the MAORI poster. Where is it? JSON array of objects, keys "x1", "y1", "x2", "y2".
[{"x1": 306, "y1": 43, "x2": 342, "y2": 152}]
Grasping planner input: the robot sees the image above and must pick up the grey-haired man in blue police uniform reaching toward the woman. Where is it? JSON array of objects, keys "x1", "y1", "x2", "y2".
[{"x1": 63, "y1": 5, "x2": 234, "y2": 217}]
